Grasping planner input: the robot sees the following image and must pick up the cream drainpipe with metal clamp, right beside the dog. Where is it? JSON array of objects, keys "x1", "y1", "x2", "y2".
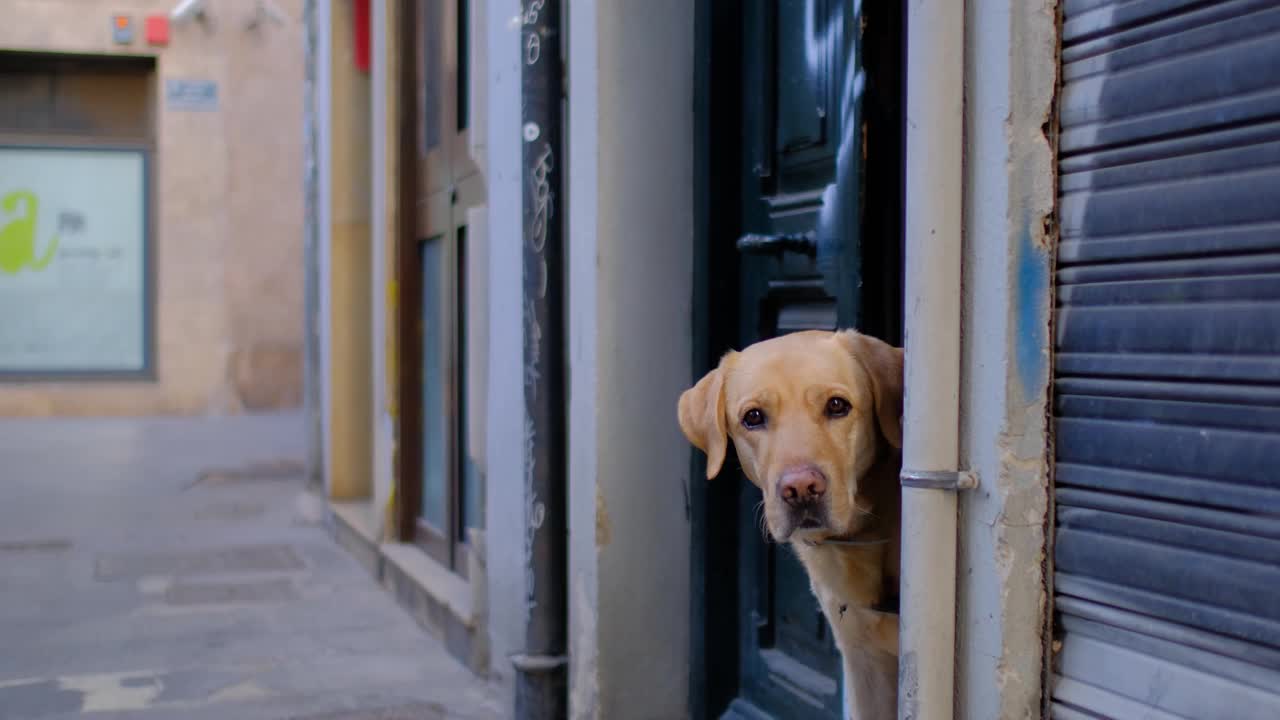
[{"x1": 899, "y1": 0, "x2": 974, "y2": 720}]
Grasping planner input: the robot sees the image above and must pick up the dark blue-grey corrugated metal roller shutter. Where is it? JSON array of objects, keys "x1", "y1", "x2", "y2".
[{"x1": 1052, "y1": 0, "x2": 1280, "y2": 720}]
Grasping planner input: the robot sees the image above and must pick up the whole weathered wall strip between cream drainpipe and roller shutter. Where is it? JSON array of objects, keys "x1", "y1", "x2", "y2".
[{"x1": 956, "y1": 0, "x2": 1057, "y2": 720}]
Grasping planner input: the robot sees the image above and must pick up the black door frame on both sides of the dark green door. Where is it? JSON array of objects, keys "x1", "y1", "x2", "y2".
[{"x1": 689, "y1": 0, "x2": 906, "y2": 719}]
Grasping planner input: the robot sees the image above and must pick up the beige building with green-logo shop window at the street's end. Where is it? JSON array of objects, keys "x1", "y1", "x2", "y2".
[{"x1": 0, "y1": 0, "x2": 303, "y2": 415}]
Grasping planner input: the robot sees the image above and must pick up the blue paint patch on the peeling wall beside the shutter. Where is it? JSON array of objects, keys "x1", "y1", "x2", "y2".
[{"x1": 1014, "y1": 218, "x2": 1050, "y2": 397}]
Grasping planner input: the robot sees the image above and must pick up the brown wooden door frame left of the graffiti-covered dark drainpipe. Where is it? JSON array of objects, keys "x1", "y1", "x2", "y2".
[{"x1": 393, "y1": 0, "x2": 484, "y2": 579}]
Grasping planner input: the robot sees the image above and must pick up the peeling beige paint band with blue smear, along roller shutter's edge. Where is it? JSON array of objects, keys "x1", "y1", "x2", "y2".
[{"x1": 995, "y1": 0, "x2": 1057, "y2": 719}]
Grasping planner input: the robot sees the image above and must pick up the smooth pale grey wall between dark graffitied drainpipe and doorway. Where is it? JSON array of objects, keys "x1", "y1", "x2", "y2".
[{"x1": 568, "y1": 0, "x2": 695, "y2": 719}]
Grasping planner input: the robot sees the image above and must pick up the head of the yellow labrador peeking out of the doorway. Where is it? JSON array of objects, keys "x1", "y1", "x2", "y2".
[{"x1": 680, "y1": 331, "x2": 902, "y2": 541}]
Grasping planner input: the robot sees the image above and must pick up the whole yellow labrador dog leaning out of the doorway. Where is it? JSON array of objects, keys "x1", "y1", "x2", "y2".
[{"x1": 680, "y1": 331, "x2": 902, "y2": 720}]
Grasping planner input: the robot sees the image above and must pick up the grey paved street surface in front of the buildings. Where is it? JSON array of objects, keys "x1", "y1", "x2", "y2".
[{"x1": 0, "y1": 414, "x2": 502, "y2": 720}]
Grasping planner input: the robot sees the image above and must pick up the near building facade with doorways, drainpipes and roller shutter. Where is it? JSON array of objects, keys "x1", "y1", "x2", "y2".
[{"x1": 314, "y1": 0, "x2": 1280, "y2": 720}]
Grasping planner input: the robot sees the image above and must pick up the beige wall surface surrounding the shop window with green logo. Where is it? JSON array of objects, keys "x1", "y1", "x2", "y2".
[{"x1": 0, "y1": 0, "x2": 303, "y2": 415}]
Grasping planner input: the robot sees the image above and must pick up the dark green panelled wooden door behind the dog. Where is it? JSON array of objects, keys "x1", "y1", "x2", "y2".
[{"x1": 708, "y1": 0, "x2": 900, "y2": 720}]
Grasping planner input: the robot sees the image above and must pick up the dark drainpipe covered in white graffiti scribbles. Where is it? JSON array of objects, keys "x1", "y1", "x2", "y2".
[{"x1": 512, "y1": 0, "x2": 568, "y2": 720}]
